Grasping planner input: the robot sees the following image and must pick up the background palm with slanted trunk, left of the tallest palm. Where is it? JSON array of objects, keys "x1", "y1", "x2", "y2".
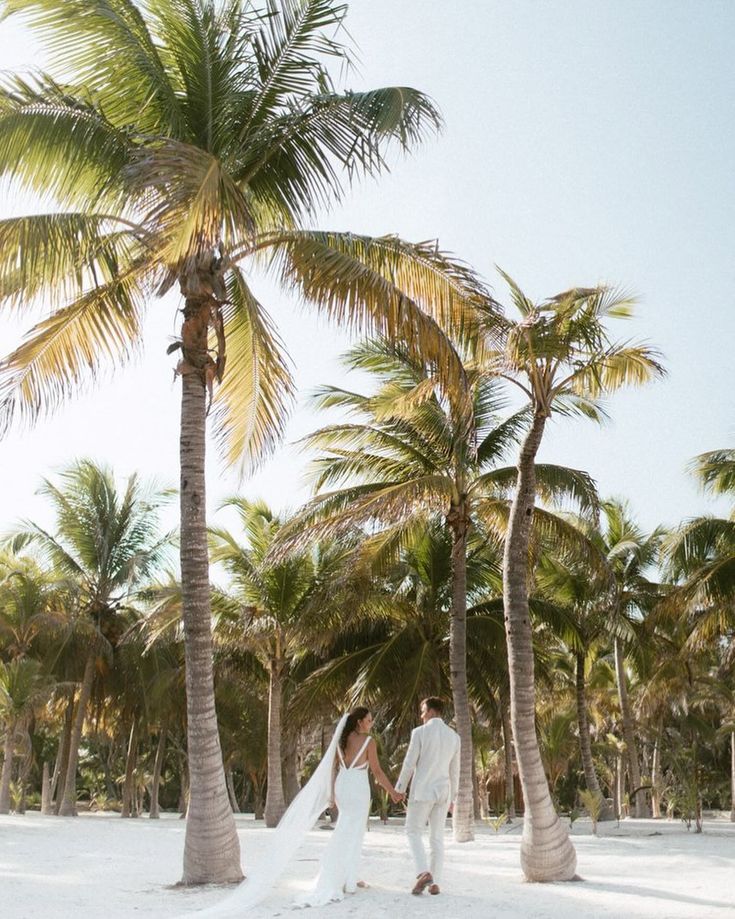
[{"x1": 13, "y1": 460, "x2": 167, "y2": 816}]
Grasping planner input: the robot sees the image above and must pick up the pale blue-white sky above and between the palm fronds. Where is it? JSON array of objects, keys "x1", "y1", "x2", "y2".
[{"x1": 0, "y1": 0, "x2": 735, "y2": 544}]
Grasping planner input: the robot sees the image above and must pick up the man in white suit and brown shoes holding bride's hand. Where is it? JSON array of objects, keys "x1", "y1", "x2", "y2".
[{"x1": 396, "y1": 696, "x2": 459, "y2": 894}]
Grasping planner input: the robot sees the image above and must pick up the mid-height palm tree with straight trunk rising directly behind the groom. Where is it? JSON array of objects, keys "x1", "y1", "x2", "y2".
[{"x1": 278, "y1": 341, "x2": 594, "y2": 841}]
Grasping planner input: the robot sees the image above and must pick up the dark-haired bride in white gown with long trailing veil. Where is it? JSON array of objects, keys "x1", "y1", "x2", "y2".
[{"x1": 198, "y1": 707, "x2": 403, "y2": 919}]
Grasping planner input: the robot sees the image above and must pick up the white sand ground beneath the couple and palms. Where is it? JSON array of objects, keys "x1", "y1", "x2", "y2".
[{"x1": 0, "y1": 813, "x2": 735, "y2": 919}]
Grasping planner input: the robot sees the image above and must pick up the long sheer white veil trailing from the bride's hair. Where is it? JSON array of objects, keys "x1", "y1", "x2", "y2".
[{"x1": 195, "y1": 714, "x2": 347, "y2": 919}]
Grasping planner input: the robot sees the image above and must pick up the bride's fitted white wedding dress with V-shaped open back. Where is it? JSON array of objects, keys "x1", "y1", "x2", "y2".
[{"x1": 296, "y1": 737, "x2": 370, "y2": 906}]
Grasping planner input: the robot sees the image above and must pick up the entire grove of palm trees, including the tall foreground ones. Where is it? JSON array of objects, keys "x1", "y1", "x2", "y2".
[{"x1": 0, "y1": 0, "x2": 735, "y2": 884}]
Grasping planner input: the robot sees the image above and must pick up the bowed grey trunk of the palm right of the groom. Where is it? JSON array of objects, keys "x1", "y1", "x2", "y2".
[{"x1": 503, "y1": 412, "x2": 577, "y2": 881}]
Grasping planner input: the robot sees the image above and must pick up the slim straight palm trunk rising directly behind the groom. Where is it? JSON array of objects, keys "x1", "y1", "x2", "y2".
[{"x1": 447, "y1": 501, "x2": 475, "y2": 842}]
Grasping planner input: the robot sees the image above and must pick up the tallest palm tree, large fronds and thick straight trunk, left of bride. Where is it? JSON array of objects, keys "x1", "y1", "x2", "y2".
[{"x1": 0, "y1": 0, "x2": 494, "y2": 884}]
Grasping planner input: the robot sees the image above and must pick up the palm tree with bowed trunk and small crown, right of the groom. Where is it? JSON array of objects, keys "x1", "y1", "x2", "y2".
[{"x1": 488, "y1": 274, "x2": 663, "y2": 881}]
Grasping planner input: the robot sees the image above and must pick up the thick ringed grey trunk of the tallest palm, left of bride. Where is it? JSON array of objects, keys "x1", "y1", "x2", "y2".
[{"x1": 180, "y1": 292, "x2": 242, "y2": 885}]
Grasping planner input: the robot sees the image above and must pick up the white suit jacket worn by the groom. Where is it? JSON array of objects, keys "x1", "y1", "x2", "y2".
[{"x1": 396, "y1": 718, "x2": 459, "y2": 801}]
